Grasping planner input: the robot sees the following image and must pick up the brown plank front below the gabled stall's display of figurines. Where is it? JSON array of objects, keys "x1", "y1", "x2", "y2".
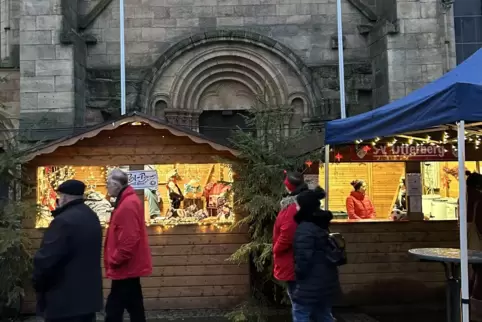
[{"x1": 24, "y1": 225, "x2": 250, "y2": 313}]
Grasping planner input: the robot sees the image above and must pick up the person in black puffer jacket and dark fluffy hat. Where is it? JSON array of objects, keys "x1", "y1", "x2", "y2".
[{"x1": 288, "y1": 187, "x2": 340, "y2": 322}]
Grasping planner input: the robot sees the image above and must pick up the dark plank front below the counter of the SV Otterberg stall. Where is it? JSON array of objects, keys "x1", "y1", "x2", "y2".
[{"x1": 331, "y1": 221, "x2": 459, "y2": 306}]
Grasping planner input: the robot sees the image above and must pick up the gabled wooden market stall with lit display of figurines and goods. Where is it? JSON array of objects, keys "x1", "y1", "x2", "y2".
[{"x1": 20, "y1": 113, "x2": 250, "y2": 312}]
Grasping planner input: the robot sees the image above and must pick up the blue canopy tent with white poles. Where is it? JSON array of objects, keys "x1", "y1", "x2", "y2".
[{"x1": 325, "y1": 49, "x2": 482, "y2": 322}]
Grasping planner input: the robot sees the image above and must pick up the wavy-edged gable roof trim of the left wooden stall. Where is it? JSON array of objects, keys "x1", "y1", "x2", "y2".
[{"x1": 25, "y1": 112, "x2": 239, "y2": 162}]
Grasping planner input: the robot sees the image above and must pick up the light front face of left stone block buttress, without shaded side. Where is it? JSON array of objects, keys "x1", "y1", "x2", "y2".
[{"x1": 20, "y1": 0, "x2": 75, "y2": 139}]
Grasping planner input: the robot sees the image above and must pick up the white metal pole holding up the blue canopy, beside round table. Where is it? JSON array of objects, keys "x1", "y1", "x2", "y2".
[{"x1": 457, "y1": 121, "x2": 469, "y2": 322}]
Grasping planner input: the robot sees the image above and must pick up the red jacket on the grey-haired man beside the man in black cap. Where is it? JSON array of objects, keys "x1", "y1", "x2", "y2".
[{"x1": 104, "y1": 186, "x2": 152, "y2": 280}]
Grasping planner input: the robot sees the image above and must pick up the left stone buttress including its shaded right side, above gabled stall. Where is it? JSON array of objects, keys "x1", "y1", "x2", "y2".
[{"x1": 20, "y1": 0, "x2": 88, "y2": 140}]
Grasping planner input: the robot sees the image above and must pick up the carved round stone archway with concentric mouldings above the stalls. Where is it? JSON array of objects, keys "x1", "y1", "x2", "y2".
[{"x1": 140, "y1": 30, "x2": 319, "y2": 129}]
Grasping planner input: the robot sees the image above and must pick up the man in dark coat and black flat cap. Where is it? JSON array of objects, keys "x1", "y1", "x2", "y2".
[{"x1": 33, "y1": 180, "x2": 103, "y2": 322}]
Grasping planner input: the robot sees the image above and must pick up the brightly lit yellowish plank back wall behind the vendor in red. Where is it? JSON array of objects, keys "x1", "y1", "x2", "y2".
[{"x1": 320, "y1": 162, "x2": 405, "y2": 218}]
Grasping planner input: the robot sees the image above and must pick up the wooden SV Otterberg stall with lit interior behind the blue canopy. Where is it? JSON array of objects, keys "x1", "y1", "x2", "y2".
[{"x1": 305, "y1": 133, "x2": 466, "y2": 310}]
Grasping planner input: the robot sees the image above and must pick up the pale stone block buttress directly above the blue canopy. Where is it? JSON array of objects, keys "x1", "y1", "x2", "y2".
[{"x1": 369, "y1": 0, "x2": 455, "y2": 107}]
